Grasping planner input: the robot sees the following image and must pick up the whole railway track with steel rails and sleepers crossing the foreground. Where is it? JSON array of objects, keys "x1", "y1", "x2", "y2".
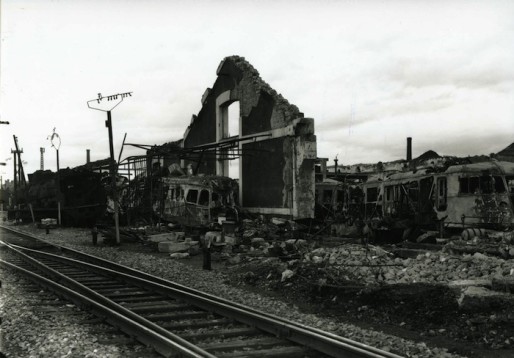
[{"x1": 0, "y1": 227, "x2": 399, "y2": 358}]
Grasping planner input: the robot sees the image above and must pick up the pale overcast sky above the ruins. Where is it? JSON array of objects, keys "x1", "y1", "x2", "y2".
[{"x1": 0, "y1": 0, "x2": 514, "y2": 180}]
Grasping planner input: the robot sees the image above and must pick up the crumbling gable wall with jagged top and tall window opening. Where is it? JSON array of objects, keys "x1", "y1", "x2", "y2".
[{"x1": 183, "y1": 56, "x2": 316, "y2": 218}]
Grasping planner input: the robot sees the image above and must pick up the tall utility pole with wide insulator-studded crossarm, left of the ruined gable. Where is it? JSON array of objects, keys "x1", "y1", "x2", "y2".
[{"x1": 87, "y1": 92, "x2": 132, "y2": 245}]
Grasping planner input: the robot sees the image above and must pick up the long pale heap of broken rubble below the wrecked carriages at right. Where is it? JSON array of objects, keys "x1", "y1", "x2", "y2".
[{"x1": 262, "y1": 240, "x2": 514, "y2": 285}]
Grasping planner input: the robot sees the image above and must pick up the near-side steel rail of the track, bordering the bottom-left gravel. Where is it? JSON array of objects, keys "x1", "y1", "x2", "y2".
[{"x1": 0, "y1": 259, "x2": 211, "y2": 358}]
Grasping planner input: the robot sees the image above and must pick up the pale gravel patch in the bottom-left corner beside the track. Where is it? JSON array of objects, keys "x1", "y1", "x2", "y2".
[{"x1": 0, "y1": 270, "x2": 157, "y2": 358}]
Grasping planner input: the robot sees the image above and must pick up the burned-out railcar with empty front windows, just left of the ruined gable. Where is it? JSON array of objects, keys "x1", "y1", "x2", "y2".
[{"x1": 152, "y1": 175, "x2": 238, "y2": 227}]
